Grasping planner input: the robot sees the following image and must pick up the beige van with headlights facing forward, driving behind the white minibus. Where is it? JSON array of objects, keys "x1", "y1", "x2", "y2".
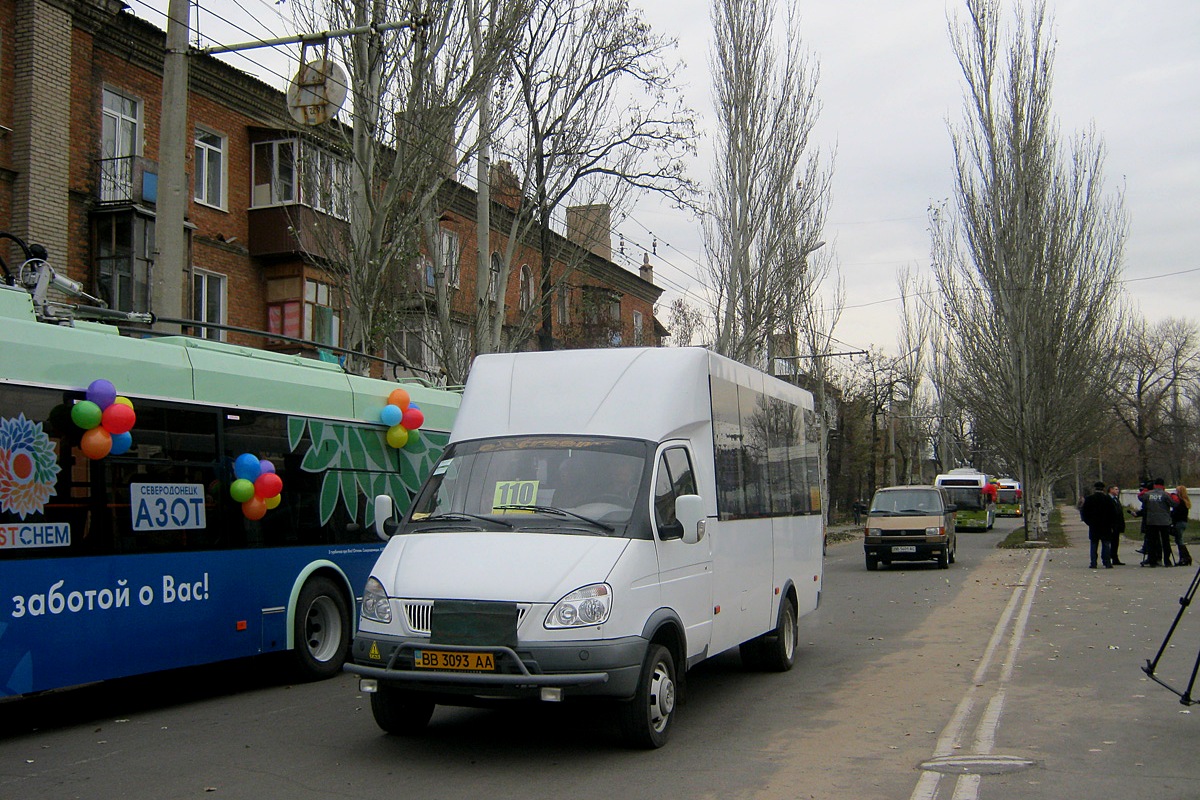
[{"x1": 863, "y1": 486, "x2": 956, "y2": 570}]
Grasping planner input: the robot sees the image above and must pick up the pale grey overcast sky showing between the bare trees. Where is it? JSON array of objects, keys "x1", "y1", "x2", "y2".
[{"x1": 136, "y1": 0, "x2": 1200, "y2": 350}]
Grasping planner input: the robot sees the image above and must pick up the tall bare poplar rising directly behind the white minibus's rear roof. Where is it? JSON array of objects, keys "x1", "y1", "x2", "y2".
[{"x1": 704, "y1": 0, "x2": 832, "y2": 367}]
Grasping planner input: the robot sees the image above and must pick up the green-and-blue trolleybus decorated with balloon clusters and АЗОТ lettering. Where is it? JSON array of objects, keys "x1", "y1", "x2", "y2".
[{"x1": 0, "y1": 264, "x2": 461, "y2": 696}]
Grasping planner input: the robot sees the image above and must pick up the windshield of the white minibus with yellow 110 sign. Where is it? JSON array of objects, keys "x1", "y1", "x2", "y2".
[{"x1": 408, "y1": 435, "x2": 653, "y2": 535}]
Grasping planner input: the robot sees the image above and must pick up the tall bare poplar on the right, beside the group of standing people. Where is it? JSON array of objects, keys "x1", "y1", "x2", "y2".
[{"x1": 931, "y1": 0, "x2": 1127, "y2": 539}]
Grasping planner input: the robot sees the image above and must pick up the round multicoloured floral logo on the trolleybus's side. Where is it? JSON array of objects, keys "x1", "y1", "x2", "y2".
[{"x1": 0, "y1": 414, "x2": 60, "y2": 519}]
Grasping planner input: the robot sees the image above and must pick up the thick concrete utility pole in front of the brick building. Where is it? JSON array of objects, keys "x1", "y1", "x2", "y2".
[{"x1": 150, "y1": 0, "x2": 192, "y2": 333}]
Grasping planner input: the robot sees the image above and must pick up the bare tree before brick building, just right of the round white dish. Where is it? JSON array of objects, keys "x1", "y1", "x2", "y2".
[{"x1": 283, "y1": 0, "x2": 527, "y2": 383}]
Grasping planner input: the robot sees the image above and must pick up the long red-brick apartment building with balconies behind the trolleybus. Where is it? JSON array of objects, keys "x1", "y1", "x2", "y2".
[{"x1": 0, "y1": 0, "x2": 665, "y2": 377}]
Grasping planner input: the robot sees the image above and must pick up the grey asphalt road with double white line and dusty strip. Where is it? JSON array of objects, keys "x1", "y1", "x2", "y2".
[{"x1": 0, "y1": 522, "x2": 1200, "y2": 800}]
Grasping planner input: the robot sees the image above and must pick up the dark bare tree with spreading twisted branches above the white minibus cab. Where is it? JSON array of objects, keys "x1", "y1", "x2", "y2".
[{"x1": 489, "y1": 0, "x2": 695, "y2": 351}]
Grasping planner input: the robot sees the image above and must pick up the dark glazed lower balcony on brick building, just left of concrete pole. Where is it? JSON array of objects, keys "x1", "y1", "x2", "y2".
[{"x1": 92, "y1": 211, "x2": 154, "y2": 312}]
